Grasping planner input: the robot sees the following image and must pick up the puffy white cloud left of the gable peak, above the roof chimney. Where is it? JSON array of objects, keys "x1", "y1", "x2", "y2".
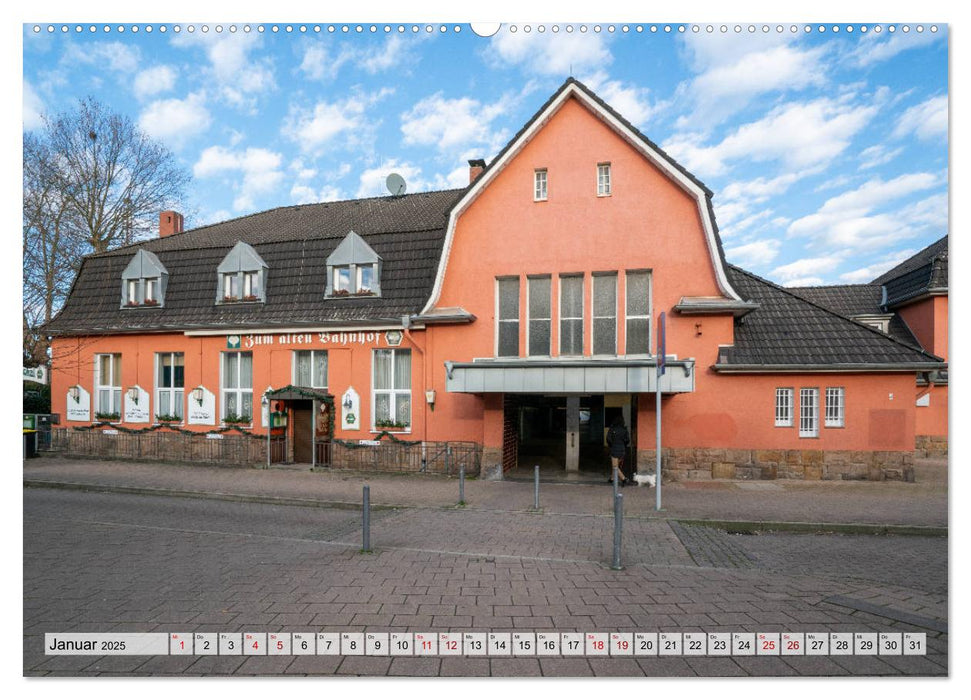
[{"x1": 401, "y1": 92, "x2": 505, "y2": 150}]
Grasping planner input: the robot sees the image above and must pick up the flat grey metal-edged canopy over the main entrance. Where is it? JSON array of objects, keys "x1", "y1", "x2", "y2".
[{"x1": 445, "y1": 358, "x2": 695, "y2": 394}]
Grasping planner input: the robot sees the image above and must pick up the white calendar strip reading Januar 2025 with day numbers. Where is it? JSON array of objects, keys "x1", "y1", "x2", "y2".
[{"x1": 44, "y1": 632, "x2": 927, "y2": 657}]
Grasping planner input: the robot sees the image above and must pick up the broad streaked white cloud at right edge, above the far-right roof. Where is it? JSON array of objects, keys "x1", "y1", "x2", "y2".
[{"x1": 788, "y1": 173, "x2": 947, "y2": 248}]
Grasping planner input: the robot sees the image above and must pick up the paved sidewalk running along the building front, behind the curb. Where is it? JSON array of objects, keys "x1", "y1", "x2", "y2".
[{"x1": 23, "y1": 457, "x2": 948, "y2": 528}]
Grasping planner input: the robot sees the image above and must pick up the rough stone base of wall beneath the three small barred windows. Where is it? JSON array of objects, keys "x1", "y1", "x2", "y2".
[{"x1": 637, "y1": 448, "x2": 914, "y2": 481}]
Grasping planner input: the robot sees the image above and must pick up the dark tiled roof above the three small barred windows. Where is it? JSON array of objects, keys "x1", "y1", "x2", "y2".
[{"x1": 718, "y1": 265, "x2": 941, "y2": 368}]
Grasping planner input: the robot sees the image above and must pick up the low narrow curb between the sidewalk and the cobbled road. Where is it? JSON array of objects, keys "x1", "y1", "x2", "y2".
[{"x1": 24, "y1": 479, "x2": 948, "y2": 537}]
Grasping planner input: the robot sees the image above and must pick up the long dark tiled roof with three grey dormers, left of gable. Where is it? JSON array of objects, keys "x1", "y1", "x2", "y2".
[{"x1": 47, "y1": 190, "x2": 463, "y2": 335}]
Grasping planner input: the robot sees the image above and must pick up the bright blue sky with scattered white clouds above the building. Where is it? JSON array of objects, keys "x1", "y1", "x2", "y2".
[{"x1": 23, "y1": 22, "x2": 948, "y2": 284}]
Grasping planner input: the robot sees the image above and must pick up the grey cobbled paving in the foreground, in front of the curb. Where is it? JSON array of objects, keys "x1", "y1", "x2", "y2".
[{"x1": 24, "y1": 489, "x2": 948, "y2": 676}]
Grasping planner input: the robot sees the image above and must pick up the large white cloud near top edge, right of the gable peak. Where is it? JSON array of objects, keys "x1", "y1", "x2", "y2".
[{"x1": 677, "y1": 36, "x2": 826, "y2": 129}]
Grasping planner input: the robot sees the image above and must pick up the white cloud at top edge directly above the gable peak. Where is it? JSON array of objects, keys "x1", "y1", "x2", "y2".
[{"x1": 486, "y1": 26, "x2": 613, "y2": 76}]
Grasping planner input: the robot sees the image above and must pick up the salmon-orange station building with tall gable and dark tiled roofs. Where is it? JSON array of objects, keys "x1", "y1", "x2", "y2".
[{"x1": 48, "y1": 79, "x2": 947, "y2": 479}]
